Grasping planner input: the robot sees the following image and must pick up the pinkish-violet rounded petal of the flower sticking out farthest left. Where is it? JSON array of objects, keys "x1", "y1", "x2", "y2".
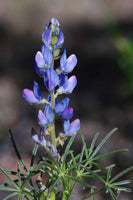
[{"x1": 23, "y1": 89, "x2": 39, "y2": 104}]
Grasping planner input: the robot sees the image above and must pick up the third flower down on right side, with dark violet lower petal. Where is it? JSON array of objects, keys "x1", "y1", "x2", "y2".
[{"x1": 55, "y1": 97, "x2": 73, "y2": 119}]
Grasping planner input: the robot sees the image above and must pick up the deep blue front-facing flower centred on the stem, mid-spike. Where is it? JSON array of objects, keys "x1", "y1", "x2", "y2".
[{"x1": 44, "y1": 68, "x2": 59, "y2": 92}]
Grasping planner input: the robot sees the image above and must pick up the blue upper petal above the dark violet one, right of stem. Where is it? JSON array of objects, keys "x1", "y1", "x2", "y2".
[{"x1": 55, "y1": 97, "x2": 70, "y2": 114}]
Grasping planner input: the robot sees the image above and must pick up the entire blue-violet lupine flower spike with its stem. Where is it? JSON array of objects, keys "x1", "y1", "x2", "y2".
[{"x1": 23, "y1": 18, "x2": 80, "y2": 156}]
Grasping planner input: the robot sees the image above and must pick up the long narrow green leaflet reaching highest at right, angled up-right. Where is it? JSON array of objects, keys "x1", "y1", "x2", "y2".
[{"x1": 90, "y1": 128, "x2": 117, "y2": 159}]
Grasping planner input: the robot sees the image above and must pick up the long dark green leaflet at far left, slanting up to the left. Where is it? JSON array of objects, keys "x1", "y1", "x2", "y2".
[{"x1": 9, "y1": 130, "x2": 28, "y2": 172}]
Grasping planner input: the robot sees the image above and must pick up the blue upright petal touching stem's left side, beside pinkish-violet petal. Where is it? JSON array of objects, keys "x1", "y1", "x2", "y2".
[{"x1": 44, "y1": 104, "x2": 55, "y2": 123}]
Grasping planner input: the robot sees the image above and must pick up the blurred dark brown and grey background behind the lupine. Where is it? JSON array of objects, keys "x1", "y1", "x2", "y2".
[{"x1": 0, "y1": 0, "x2": 133, "y2": 200}]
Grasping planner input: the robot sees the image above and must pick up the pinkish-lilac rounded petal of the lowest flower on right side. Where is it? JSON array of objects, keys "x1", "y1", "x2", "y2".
[{"x1": 65, "y1": 119, "x2": 80, "y2": 136}]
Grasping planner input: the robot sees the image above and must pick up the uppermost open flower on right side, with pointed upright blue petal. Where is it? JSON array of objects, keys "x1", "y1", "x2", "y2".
[{"x1": 57, "y1": 49, "x2": 77, "y2": 73}]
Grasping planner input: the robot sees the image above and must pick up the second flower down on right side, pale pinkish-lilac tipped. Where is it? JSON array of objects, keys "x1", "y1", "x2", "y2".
[{"x1": 57, "y1": 76, "x2": 77, "y2": 94}]
